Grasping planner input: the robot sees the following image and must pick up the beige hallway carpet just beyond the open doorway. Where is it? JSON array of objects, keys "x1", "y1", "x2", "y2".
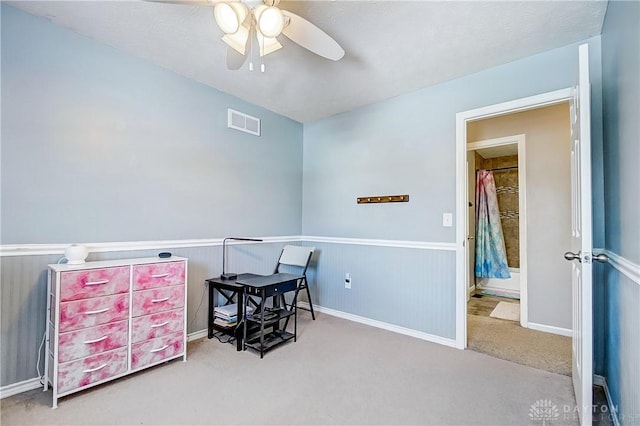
[{"x1": 467, "y1": 315, "x2": 571, "y2": 376}]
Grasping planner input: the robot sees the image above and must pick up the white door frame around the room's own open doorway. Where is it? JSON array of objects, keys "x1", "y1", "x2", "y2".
[{"x1": 455, "y1": 87, "x2": 573, "y2": 349}]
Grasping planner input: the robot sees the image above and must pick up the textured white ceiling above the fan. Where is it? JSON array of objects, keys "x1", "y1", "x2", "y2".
[{"x1": 8, "y1": 0, "x2": 607, "y2": 123}]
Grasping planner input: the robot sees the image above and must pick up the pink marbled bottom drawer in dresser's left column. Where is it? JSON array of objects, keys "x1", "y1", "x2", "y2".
[{"x1": 58, "y1": 348, "x2": 127, "y2": 393}]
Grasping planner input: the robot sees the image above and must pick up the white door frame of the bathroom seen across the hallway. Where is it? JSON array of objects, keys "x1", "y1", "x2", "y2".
[{"x1": 465, "y1": 134, "x2": 529, "y2": 328}]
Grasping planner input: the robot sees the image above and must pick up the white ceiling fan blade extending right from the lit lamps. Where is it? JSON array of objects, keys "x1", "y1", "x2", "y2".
[{"x1": 282, "y1": 10, "x2": 344, "y2": 61}]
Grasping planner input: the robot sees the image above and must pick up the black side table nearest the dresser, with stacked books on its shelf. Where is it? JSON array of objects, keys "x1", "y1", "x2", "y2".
[{"x1": 205, "y1": 274, "x2": 260, "y2": 351}]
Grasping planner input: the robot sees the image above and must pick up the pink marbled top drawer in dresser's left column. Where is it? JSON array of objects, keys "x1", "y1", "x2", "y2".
[{"x1": 60, "y1": 266, "x2": 131, "y2": 302}]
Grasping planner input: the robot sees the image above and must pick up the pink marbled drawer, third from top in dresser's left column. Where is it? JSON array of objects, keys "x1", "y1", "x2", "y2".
[{"x1": 58, "y1": 321, "x2": 129, "y2": 362}]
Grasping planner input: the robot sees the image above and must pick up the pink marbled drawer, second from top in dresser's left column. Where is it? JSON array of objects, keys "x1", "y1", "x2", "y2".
[{"x1": 59, "y1": 293, "x2": 129, "y2": 333}]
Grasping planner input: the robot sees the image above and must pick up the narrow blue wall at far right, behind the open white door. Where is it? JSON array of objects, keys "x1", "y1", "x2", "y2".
[{"x1": 602, "y1": 1, "x2": 640, "y2": 424}]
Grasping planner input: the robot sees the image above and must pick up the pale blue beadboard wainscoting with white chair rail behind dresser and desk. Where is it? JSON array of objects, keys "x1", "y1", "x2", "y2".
[{"x1": 0, "y1": 235, "x2": 455, "y2": 398}]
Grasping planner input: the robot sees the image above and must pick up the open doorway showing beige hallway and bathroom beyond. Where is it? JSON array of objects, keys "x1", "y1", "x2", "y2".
[{"x1": 466, "y1": 102, "x2": 571, "y2": 375}]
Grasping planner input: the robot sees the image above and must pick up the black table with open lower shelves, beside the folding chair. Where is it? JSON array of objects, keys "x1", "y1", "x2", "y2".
[{"x1": 236, "y1": 273, "x2": 303, "y2": 358}]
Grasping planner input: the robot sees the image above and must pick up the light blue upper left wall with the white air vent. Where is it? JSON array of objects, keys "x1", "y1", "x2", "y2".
[{"x1": 1, "y1": 4, "x2": 302, "y2": 244}]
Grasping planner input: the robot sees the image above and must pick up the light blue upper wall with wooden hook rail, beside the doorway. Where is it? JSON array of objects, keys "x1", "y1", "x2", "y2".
[{"x1": 302, "y1": 37, "x2": 602, "y2": 242}]
